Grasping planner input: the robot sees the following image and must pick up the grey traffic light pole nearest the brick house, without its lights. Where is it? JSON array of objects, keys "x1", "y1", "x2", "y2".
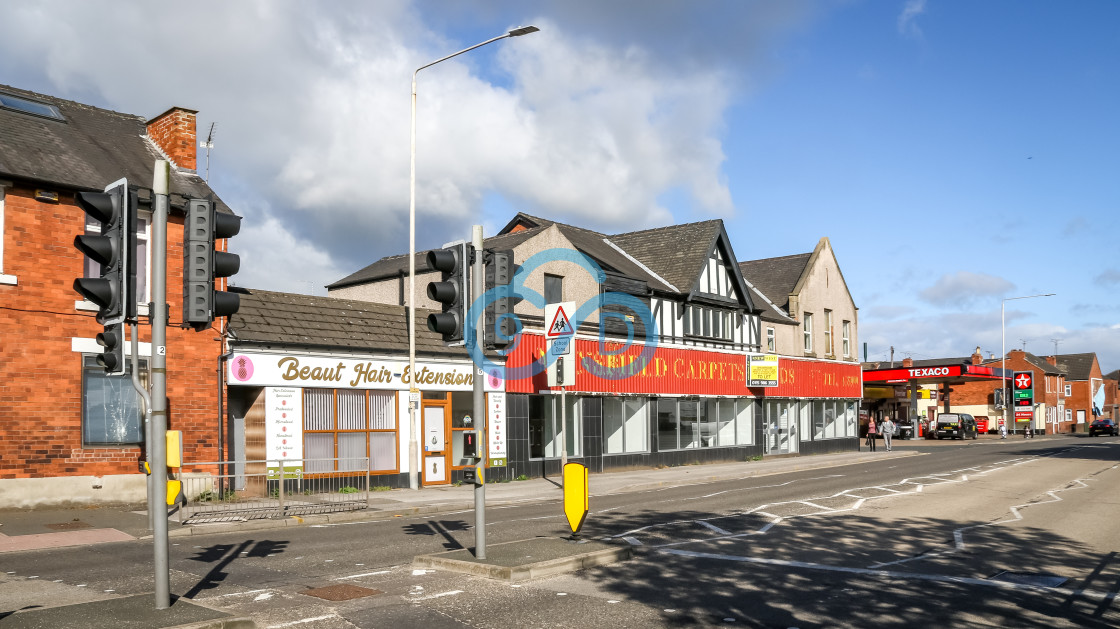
[{"x1": 148, "y1": 160, "x2": 171, "y2": 609}]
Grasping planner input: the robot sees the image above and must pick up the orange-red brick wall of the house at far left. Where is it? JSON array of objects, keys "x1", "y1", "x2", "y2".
[{"x1": 0, "y1": 181, "x2": 220, "y2": 479}]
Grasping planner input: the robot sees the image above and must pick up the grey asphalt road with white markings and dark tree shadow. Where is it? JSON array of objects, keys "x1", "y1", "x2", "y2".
[{"x1": 3, "y1": 438, "x2": 1120, "y2": 629}]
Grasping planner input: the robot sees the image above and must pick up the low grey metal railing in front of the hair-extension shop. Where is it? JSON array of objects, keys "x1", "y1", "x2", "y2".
[{"x1": 178, "y1": 458, "x2": 371, "y2": 524}]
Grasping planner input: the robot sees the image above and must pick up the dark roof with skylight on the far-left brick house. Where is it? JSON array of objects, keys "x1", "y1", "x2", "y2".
[{"x1": 0, "y1": 85, "x2": 230, "y2": 212}]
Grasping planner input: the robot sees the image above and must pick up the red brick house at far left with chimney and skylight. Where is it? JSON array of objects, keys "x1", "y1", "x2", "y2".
[{"x1": 0, "y1": 85, "x2": 230, "y2": 507}]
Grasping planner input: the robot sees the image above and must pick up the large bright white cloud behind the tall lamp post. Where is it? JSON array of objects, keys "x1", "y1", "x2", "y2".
[{"x1": 0, "y1": 0, "x2": 743, "y2": 288}]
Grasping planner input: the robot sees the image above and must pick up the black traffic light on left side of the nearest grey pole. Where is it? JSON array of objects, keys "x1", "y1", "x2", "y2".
[{"x1": 74, "y1": 179, "x2": 137, "y2": 375}]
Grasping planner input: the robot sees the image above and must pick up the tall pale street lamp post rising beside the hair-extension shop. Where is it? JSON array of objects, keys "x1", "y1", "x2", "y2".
[{"x1": 409, "y1": 26, "x2": 540, "y2": 489}]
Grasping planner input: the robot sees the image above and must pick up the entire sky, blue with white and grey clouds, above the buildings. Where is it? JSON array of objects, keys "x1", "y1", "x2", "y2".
[{"x1": 0, "y1": 0, "x2": 1120, "y2": 372}]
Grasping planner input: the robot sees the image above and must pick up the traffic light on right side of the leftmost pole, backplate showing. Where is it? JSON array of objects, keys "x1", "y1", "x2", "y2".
[{"x1": 183, "y1": 199, "x2": 241, "y2": 331}]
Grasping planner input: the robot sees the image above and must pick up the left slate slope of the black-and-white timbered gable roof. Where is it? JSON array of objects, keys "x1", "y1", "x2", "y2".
[{"x1": 610, "y1": 220, "x2": 722, "y2": 294}]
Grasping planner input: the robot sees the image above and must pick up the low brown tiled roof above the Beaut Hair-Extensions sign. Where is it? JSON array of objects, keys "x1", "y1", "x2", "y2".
[{"x1": 228, "y1": 289, "x2": 467, "y2": 358}]
